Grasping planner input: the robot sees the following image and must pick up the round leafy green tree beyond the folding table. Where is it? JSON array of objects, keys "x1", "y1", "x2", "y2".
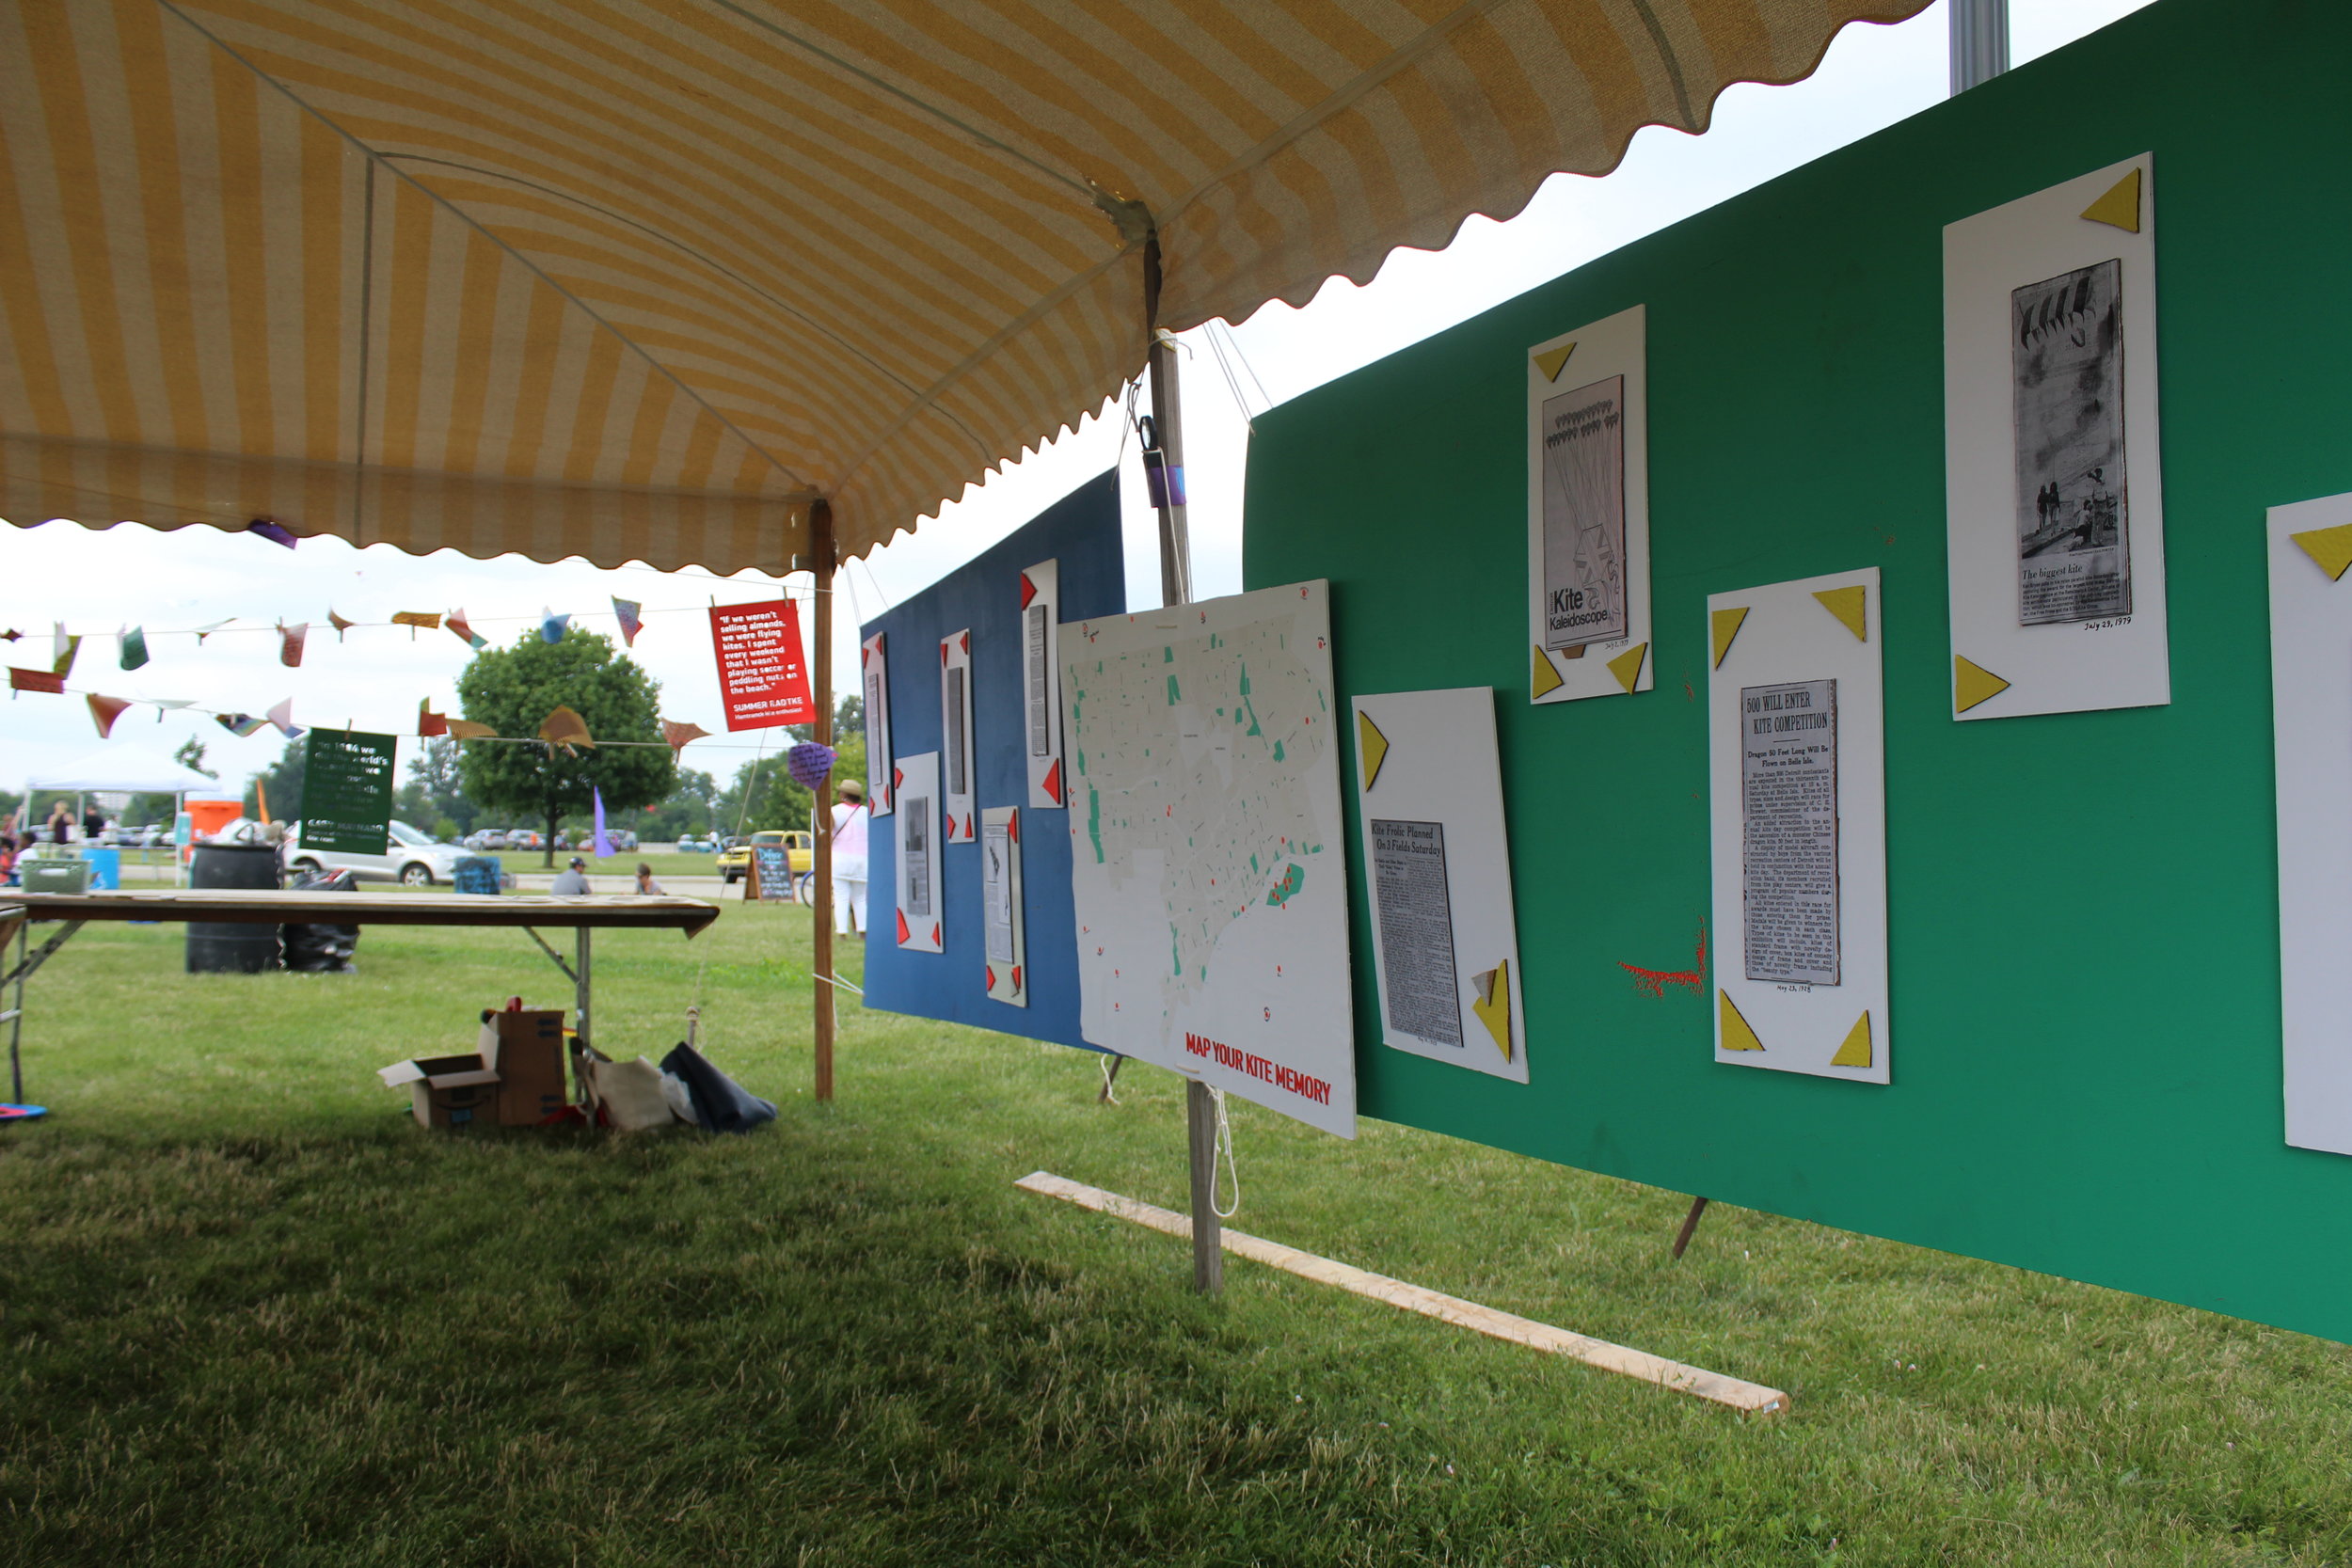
[{"x1": 456, "y1": 630, "x2": 677, "y2": 865}]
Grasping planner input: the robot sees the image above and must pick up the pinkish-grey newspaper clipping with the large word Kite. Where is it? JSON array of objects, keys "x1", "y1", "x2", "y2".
[{"x1": 1543, "y1": 376, "x2": 1626, "y2": 649}]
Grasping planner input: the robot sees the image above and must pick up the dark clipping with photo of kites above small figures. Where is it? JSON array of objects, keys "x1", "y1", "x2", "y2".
[{"x1": 2009, "y1": 261, "x2": 2131, "y2": 626}]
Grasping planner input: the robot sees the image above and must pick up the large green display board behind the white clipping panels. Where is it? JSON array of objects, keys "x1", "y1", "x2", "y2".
[{"x1": 1245, "y1": 0, "x2": 2352, "y2": 1340}]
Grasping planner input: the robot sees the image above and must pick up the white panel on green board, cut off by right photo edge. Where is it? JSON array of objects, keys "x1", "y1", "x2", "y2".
[{"x1": 2270, "y1": 496, "x2": 2352, "y2": 1154}]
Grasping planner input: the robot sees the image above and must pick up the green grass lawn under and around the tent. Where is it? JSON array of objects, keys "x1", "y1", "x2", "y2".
[{"x1": 0, "y1": 905, "x2": 2352, "y2": 1568}]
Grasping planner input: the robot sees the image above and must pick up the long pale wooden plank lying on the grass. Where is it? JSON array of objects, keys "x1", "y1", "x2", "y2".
[{"x1": 1014, "y1": 1171, "x2": 1788, "y2": 1416}]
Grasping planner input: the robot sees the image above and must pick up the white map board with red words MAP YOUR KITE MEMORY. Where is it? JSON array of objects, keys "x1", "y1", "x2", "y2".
[{"x1": 1061, "y1": 580, "x2": 1355, "y2": 1138}]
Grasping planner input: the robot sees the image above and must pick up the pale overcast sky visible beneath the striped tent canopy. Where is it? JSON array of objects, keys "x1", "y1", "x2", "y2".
[{"x1": 0, "y1": 0, "x2": 2148, "y2": 790}]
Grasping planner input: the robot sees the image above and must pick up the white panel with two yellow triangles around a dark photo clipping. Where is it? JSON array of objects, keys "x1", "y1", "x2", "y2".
[{"x1": 1943, "y1": 152, "x2": 2173, "y2": 720}]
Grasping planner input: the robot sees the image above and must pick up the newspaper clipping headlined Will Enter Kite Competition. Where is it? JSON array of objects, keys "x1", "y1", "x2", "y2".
[{"x1": 1740, "y1": 679, "x2": 1839, "y2": 985}]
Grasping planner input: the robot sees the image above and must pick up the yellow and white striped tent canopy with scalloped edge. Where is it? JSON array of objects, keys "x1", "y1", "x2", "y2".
[{"x1": 0, "y1": 0, "x2": 1924, "y2": 571}]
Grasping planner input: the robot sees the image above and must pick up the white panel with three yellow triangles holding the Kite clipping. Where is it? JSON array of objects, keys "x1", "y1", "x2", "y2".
[{"x1": 1527, "y1": 306, "x2": 1656, "y2": 703}]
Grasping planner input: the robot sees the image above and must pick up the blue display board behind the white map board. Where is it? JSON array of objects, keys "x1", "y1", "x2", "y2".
[{"x1": 864, "y1": 470, "x2": 1127, "y2": 1046}]
